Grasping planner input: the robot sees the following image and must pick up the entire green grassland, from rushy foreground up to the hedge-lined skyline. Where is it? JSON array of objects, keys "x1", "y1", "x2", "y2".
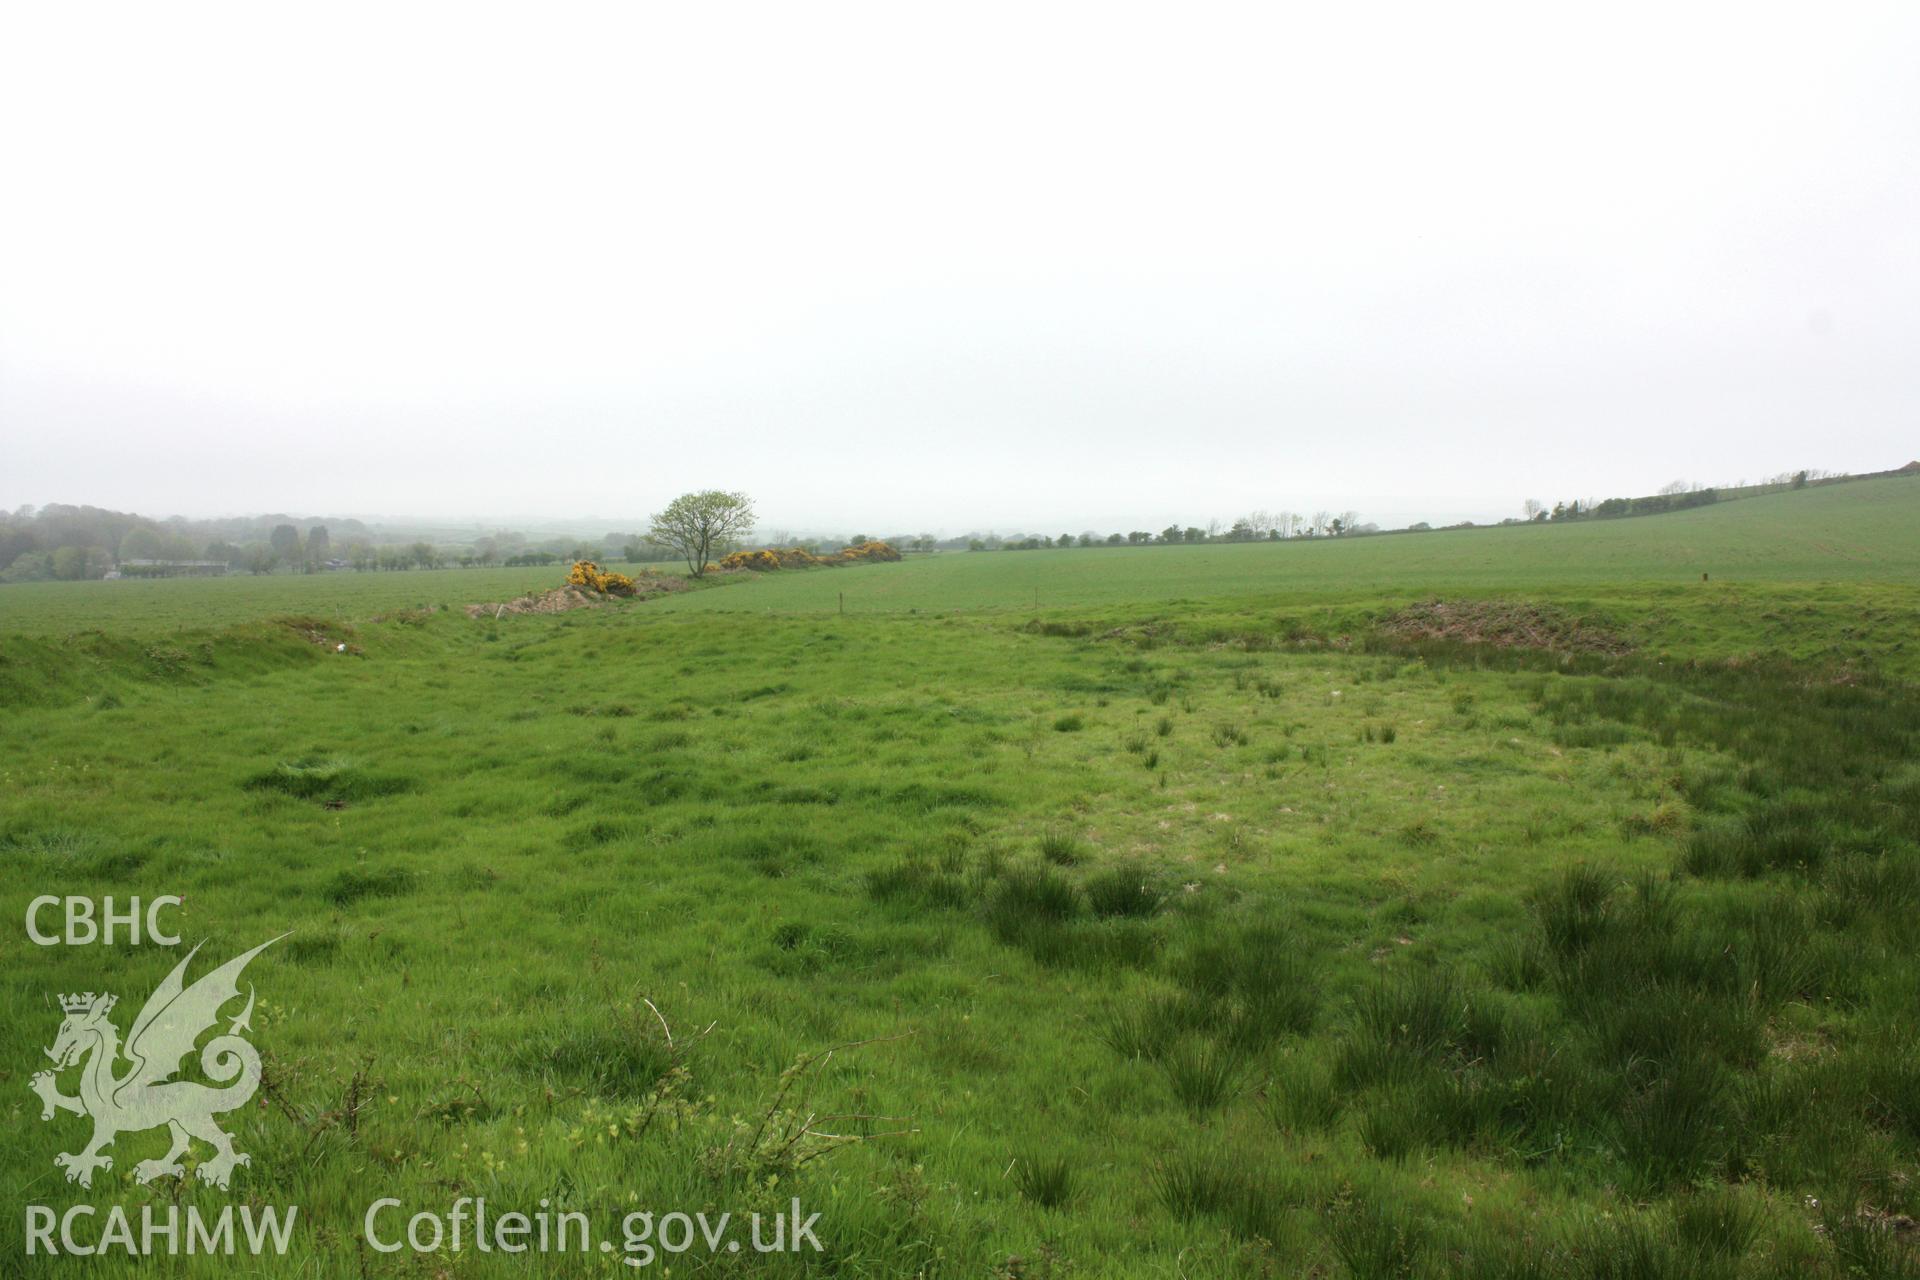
[{"x1": 0, "y1": 480, "x2": 1920, "y2": 1278}]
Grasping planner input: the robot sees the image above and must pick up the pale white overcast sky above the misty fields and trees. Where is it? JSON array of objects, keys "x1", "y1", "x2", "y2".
[{"x1": 0, "y1": 0, "x2": 1920, "y2": 533}]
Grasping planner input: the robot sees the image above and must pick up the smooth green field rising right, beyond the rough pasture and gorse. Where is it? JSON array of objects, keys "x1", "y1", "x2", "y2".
[{"x1": 659, "y1": 478, "x2": 1920, "y2": 612}]
